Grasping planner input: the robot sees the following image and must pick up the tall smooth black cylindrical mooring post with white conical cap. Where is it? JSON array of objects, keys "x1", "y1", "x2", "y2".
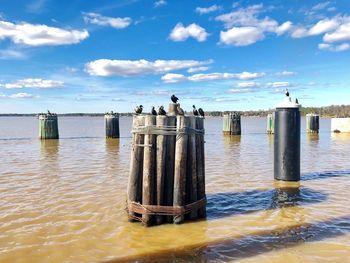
[{"x1": 274, "y1": 96, "x2": 300, "y2": 181}]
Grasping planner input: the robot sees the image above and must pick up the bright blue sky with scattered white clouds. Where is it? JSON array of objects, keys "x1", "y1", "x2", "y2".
[{"x1": 0, "y1": 0, "x2": 350, "y2": 113}]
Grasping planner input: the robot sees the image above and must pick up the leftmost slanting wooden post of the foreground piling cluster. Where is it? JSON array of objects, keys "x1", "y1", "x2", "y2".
[{"x1": 127, "y1": 115, "x2": 145, "y2": 221}]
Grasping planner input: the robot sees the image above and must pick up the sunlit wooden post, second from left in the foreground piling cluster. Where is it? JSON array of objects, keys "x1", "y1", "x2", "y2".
[{"x1": 142, "y1": 115, "x2": 156, "y2": 226}]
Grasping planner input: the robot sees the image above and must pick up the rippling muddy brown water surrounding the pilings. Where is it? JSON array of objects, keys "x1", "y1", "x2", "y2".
[{"x1": 0, "y1": 117, "x2": 350, "y2": 262}]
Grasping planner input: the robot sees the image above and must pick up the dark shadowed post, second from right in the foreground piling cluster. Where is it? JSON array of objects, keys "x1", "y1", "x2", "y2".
[{"x1": 186, "y1": 116, "x2": 198, "y2": 220}]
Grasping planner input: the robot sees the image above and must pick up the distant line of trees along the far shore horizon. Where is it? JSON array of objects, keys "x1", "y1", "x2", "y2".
[{"x1": 0, "y1": 105, "x2": 350, "y2": 118}]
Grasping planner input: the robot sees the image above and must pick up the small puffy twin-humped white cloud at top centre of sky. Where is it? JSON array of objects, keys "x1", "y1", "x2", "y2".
[{"x1": 169, "y1": 23, "x2": 209, "y2": 42}]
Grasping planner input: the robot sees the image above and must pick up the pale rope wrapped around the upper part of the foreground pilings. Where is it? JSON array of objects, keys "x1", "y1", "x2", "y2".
[{"x1": 131, "y1": 125, "x2": 204, "y2": 136}]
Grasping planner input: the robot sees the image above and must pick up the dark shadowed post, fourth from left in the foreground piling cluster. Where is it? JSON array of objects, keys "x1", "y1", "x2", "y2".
[{"x1": 164, "y1": 116, "x2": 176, "y2": 223}]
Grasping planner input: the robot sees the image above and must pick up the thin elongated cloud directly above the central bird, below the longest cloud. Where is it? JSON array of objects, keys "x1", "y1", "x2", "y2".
[{"x1": 162, "y1": 72, "x2": 265, "y2": 83}]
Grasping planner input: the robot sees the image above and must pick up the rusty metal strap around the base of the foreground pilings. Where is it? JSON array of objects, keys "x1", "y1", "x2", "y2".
[{"x1": 126, "y1": 197, "x2": 207, "y2": 220}]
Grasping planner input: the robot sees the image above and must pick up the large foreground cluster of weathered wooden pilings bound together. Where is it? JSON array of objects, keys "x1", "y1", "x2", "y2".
[{"x1": 127, "y1": 103, "x2": 206, "y2": 226}]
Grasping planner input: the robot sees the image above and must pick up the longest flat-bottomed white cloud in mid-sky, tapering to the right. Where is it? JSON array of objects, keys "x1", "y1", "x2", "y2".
[{"x1": 85, "y1": 59, "x2": 213, "y2": 77}]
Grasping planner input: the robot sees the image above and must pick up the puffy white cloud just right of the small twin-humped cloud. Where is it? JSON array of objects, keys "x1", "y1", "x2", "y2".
[{"x1": 220, "y1": 27, "x2": 264, "y2": 46}]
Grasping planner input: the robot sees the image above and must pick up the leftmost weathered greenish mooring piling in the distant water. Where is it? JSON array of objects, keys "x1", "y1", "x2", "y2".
[{"x1": 39, "y1": 111, "x2": 59, "y2": 140}]
